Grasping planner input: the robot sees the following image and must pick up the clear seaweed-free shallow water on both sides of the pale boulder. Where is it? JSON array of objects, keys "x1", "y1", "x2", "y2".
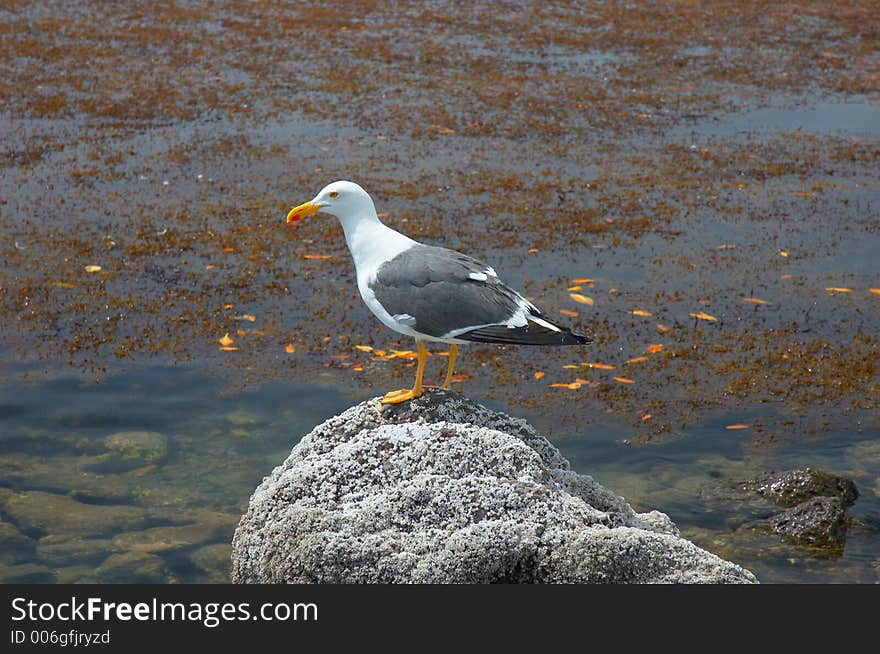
[{"x1": 0, "y1": 358, "x2": 880, "y2": 583}]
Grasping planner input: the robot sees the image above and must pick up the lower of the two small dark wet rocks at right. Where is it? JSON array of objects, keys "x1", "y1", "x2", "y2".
[{"x1": 770, "y1": 497, "x2": 846, "y2": 551}]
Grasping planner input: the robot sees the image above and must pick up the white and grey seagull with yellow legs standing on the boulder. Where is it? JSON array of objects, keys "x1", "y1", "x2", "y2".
[{"x1": 287, "y1": 181, "x2": 592, "y2": 404}]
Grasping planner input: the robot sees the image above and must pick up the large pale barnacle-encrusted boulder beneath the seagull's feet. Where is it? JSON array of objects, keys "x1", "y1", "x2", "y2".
[{"x1": 232, "y1": 390, "x2": 756, "y2": 583}]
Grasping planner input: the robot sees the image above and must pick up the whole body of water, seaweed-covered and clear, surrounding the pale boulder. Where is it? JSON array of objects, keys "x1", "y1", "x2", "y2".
[{"x1": 0, "y1": 0, "x2": 880, "y2": 582}]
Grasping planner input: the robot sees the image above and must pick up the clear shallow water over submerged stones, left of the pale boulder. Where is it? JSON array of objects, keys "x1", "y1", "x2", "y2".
[{"x1": 0, "y1": 363, "x2": 364, "y2": 583}]
